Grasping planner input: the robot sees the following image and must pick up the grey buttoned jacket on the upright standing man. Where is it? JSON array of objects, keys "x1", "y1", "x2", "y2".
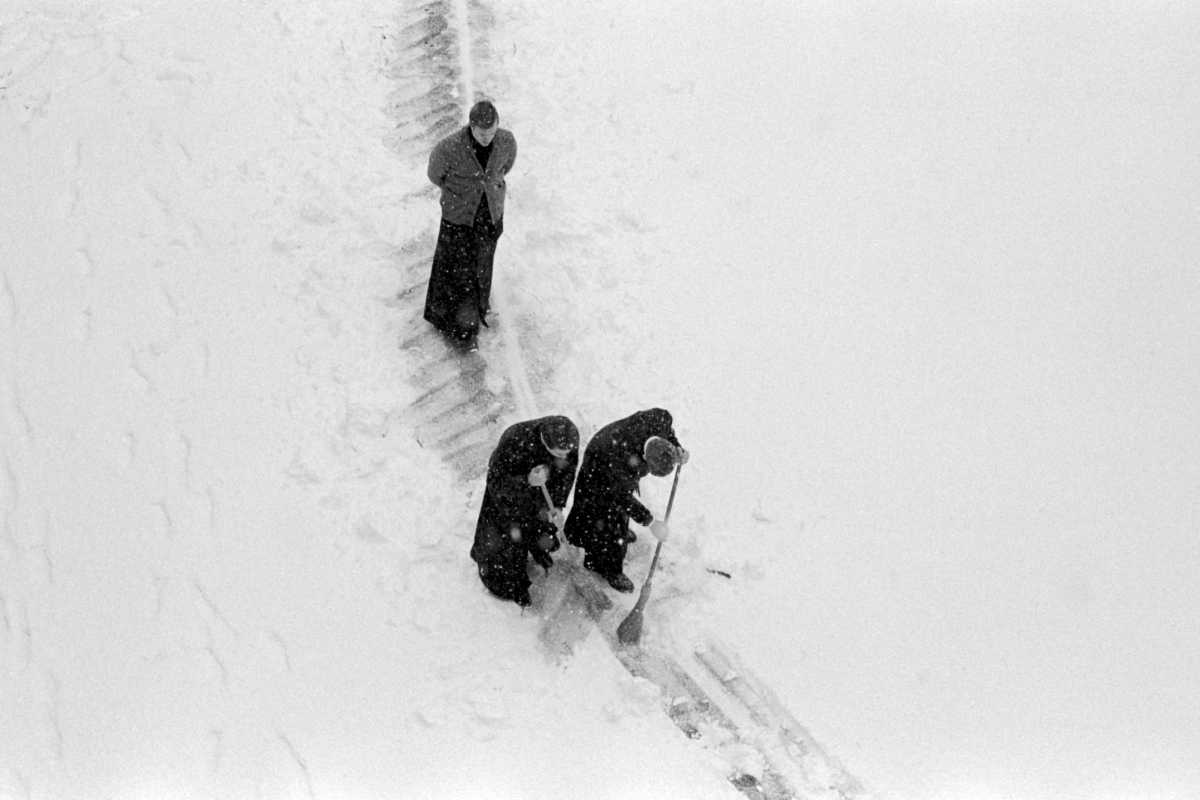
[{"x1": 428, "y1": 126, "x2": 517, "y2": 225}]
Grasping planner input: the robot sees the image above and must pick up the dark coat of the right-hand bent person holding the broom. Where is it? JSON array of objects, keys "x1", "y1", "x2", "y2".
[{"x1": 565, "y1": 408, "x2": 679, "y2": 549}]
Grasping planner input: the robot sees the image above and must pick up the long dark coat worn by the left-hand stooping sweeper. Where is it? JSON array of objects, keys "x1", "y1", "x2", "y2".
[{"x1": 470, "y1": 417, "x2": 580, "y2": 596}]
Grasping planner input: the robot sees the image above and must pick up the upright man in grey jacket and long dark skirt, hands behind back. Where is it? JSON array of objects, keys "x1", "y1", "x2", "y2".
[{"x1": 425, "y1": 100, "x2": 517, "y2": 349}]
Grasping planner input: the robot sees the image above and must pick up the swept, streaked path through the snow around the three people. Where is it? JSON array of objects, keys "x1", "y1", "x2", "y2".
[{"x1": 390, "y1": 0, "x2": 865, "y2": 800}]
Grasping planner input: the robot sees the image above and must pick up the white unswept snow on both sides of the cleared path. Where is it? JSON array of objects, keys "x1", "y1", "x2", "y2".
[{"x1": 0, "y1": 0, "x2": 1200, "y2": 800}]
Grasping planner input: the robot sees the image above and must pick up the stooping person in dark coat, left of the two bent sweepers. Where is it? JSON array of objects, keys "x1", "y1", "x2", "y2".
[{"x1": 470, "y1": 416, "x2": 580, "y2": 606}]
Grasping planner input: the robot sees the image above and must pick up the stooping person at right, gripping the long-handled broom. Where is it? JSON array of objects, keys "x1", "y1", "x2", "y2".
[{"x1": 565, "y1": 408, "x2": 688, "y2": 591}]
